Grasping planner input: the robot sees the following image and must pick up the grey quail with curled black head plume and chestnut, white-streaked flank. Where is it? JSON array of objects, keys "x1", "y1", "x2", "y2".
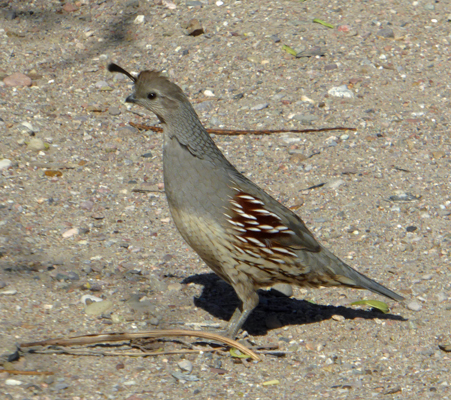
[{"x1": 108, "y1": 64, "x2": 403, "y2": 338}]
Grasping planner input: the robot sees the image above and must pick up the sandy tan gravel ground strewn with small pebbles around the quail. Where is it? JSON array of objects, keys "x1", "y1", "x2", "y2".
[{"x1": 0, "y1": 0, "x2": 451, "y2": 399}]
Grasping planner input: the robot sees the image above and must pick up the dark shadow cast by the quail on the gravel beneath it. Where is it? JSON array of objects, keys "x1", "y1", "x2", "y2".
[{"x1": 183, "y1": 273, "x2": 407, "y2": 335}]
